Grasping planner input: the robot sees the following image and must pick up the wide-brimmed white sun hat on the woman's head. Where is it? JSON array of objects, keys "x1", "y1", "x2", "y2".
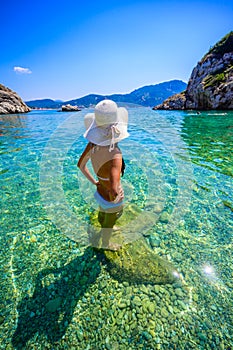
[{"x1": 83, "y1": 100, "x2": 129, "y2": 152}]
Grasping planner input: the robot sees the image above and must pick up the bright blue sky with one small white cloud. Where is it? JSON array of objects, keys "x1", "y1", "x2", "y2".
[{"x1": 0, "y1": 0, "x2": 233, "y2": 100}]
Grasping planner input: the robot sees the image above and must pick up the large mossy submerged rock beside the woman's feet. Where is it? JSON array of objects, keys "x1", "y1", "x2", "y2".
[{"x1": 104, "y1": 239, "x2": 179, "y2": 284}]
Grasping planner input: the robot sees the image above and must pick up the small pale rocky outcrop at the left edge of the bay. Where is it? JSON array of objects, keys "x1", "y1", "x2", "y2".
[{"x1": 0, "y1": 84, "x2": 30, "y2": 114}]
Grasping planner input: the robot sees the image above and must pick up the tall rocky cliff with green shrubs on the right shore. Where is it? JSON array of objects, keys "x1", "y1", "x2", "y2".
[{"x1": 153, "y1": 32, "x2": 233, "y2": 110}]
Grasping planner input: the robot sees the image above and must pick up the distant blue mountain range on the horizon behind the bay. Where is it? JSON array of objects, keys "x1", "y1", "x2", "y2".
[{"x1": 26, "y1": 80, "x2": 187, "y2": 108}]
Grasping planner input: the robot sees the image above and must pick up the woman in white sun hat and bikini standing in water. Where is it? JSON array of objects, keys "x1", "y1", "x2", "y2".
[{"x1": 78, "y1": 100, "x2": 129, "y2": 250}]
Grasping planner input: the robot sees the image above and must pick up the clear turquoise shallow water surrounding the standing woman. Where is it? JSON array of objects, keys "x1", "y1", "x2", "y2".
[{"x1": 0, "y1": 108, "x2": 233, "y2": 349}]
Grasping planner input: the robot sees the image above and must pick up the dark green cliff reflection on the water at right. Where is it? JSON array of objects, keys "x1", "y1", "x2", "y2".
[{"x1": 181, "y1": 112, "x2": 233, "y2": 176}]
